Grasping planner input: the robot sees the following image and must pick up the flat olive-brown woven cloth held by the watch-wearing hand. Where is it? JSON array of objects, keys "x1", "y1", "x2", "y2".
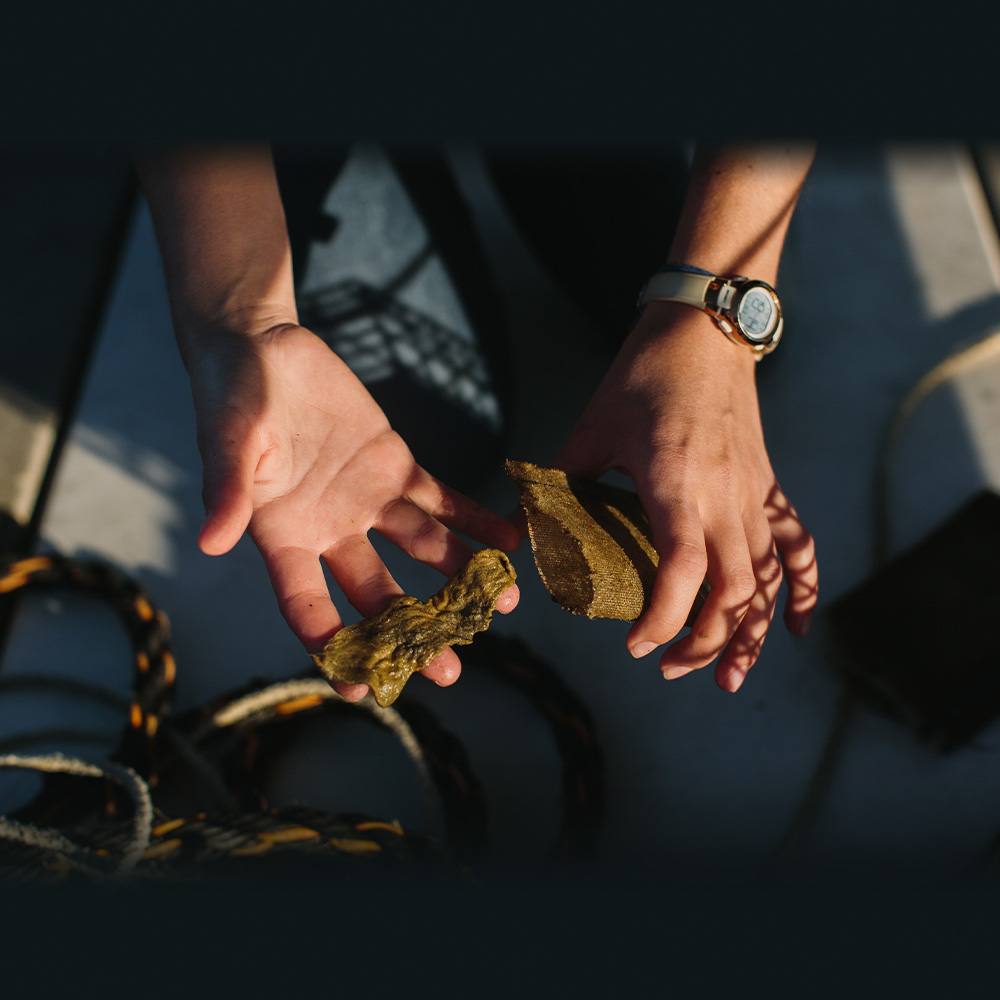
[{"x1": 506, "y1": 460, "x2": 708, "y2": 625}]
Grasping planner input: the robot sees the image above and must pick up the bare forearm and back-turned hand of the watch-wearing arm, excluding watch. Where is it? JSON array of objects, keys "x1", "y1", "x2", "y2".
[{"x1": 555, "y1": 139, "x2": 817, "y2": 691}]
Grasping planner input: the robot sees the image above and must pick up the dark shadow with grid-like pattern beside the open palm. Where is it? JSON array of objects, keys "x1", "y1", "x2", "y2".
[{"x1": 275, "y1": 143, "x2": 510, "y2": 493}]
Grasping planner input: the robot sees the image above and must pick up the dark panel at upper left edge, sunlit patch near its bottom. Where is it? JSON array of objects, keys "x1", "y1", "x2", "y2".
[{"x1": 0, "y1": 149, "x2": 134, "y2": 552}]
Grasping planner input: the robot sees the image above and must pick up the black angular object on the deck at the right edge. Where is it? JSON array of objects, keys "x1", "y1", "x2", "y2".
[{"x1": 829, "y1": 491, "x2": 1000, "y2": 751}]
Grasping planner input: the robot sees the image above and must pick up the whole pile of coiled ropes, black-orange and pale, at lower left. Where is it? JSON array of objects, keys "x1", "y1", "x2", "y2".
[{"x1": 0, "y1": 554, "x2": 604, "y2": 881}]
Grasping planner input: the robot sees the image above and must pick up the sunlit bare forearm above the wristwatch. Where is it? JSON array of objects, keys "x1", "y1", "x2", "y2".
[{"x1": 670, "y1": 143, "x2": 815, "y2": 284}]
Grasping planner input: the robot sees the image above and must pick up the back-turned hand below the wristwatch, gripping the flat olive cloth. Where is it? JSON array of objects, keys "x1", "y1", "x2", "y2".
[{"x1": 552, "y1": 302, "x2": 818, "y2": 691}]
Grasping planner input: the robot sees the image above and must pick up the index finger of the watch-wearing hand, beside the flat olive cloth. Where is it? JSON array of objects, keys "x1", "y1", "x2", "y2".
[{"x1": 625, "y1": 504, "x2": 708, "y2": 657}]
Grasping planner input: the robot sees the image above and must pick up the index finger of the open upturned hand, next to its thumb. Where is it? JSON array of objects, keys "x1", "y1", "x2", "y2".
[{"x1": 258, "y1": 544, "x2": 368, "y2": 701}]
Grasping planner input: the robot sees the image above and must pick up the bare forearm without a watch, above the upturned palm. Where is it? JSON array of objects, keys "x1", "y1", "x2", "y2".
[{"x1": 135, "y1": 139, "x2": 297, "y2": 359}]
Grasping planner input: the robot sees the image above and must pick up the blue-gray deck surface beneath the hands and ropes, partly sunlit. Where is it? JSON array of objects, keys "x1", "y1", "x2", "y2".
[{"x1": 0, "y1": 146, "x2": 1000, "y2": 878}]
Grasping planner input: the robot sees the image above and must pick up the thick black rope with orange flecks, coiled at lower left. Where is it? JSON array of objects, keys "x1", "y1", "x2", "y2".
[{"x1": 0, "y1": 555, "x2": 604, "y2": 878}]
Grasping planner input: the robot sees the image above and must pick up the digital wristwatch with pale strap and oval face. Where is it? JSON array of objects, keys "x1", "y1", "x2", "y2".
[{"x1": 637, "y1": 264, "x2": 784, "y2": 361}]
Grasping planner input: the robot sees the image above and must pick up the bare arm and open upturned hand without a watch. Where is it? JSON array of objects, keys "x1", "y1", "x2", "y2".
[{"x1": 137, "y1": 147, "x2": 519, "y2": 700}]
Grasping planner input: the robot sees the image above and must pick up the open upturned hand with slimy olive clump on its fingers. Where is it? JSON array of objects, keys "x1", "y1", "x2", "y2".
[{"x1": 185, "y1": 324, "x2": 520, "y2": 701}]
